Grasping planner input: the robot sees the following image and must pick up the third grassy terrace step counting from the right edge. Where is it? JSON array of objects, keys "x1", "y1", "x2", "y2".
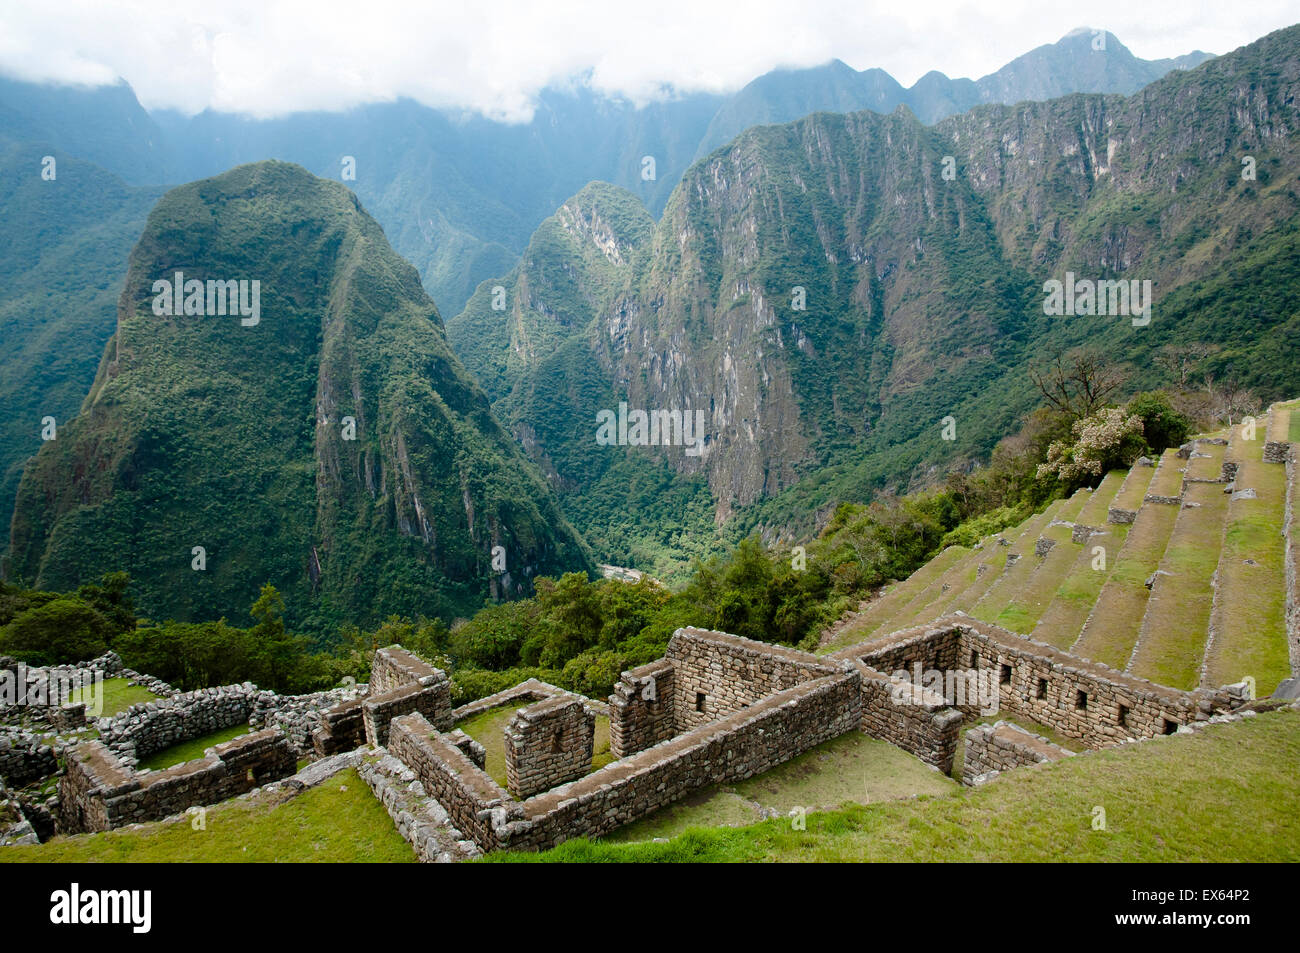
[{"x1": 1070, "y1": 478, "x2": 1185, "y2": 668}]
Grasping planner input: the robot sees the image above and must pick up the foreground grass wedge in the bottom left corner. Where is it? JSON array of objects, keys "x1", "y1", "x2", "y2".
[{"x1": 0, "y1": 768, "x2": 415, "y2": 863}]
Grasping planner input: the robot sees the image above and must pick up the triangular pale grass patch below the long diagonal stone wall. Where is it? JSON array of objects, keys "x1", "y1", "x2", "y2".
[{"x1": 605, "y1": 731, "x2": 957, "y2": 841}]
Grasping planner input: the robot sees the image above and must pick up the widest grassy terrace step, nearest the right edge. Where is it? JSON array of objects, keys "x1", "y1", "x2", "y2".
[{"x1": 1201, "y1": 455, "x2": 1300, "y2": 696}]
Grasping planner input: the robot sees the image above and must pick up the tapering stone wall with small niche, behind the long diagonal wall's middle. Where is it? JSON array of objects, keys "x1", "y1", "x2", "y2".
[{"x1": 664, "y1": 628, "x2": 839, "y2": 732}]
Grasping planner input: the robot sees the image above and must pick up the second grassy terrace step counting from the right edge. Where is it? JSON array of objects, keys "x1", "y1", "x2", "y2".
[{"x1": 1128, "y1": 478, "x2": 1227, "y2": 689}]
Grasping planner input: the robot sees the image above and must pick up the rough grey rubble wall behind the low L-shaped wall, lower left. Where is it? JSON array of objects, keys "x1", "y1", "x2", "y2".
[{"x1": 96, "y1": 681, "x2": 257, "y2": 761}]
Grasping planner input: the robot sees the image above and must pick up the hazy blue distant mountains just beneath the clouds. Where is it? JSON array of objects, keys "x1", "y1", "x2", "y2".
[{"x1": 0, "y1": 31, "x2": 1208, "y2": 315}]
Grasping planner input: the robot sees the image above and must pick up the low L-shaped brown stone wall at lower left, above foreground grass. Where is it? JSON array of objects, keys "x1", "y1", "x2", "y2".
[{"x1": 59, "y1": 728, "x2": 296, "y2": 833}]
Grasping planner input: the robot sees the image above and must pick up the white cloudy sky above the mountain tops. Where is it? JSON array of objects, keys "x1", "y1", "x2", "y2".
[{"x1": 0, "y1": 0, "x2": 1300, "y2": 120}]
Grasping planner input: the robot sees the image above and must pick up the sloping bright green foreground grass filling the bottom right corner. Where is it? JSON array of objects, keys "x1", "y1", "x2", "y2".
[{"x1": 488, "y1": 711, "x2": 1300, "y2": 863}]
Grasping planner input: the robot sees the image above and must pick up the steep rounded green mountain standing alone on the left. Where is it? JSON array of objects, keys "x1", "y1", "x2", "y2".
[{"x1": 8, "y1": 163, "x2": 590, "y2": 631}]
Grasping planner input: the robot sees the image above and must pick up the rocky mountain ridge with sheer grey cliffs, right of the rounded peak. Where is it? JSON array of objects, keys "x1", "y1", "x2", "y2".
[{"x1": 452, "y1": 20, "x2": 1300, "y2": 556}]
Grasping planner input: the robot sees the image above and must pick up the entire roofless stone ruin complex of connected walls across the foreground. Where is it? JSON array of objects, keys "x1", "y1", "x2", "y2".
[{"x1": 0, "y1": 612, "x2": 1279, "y2": 861}]
